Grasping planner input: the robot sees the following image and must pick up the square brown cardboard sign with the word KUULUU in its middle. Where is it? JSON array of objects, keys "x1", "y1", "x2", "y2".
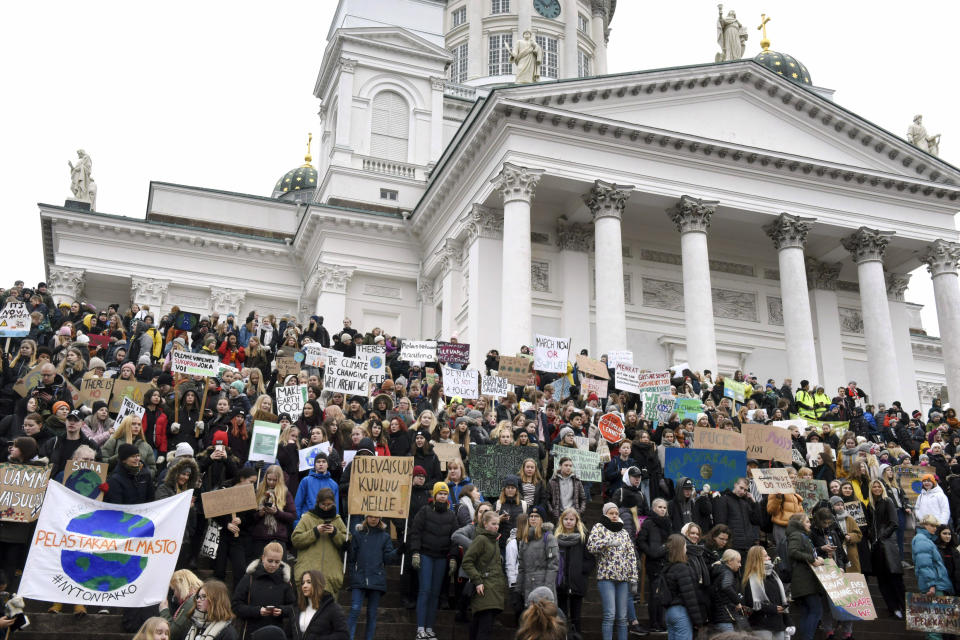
[{"x1": 347, "y1": 456, "x2": 413, "y2": 518}]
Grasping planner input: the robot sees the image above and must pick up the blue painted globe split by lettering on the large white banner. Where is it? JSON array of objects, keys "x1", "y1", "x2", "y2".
[{"x1": 60, "y1": 508, "x2": 154, "y2": 591}]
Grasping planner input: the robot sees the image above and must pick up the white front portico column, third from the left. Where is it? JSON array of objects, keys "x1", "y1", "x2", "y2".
[{"x1": 667, "y1": 196, "x2": 719, "y2": 374}]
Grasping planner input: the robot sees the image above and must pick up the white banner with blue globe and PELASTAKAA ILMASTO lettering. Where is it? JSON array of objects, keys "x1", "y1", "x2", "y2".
[{"x1": 19, "y1": 482, "x2": 193, "y2": 607}]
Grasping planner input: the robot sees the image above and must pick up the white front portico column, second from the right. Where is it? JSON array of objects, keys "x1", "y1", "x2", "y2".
[{"x1": 840, "y1": 227, "x2": 900, "y2": 405}]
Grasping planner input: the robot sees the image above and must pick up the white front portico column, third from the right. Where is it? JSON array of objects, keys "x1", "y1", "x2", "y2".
[{"x1": 763, "y1": 213, "x2": 817, "y2": 384}]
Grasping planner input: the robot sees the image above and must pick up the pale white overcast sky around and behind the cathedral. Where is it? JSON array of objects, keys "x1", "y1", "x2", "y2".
[{"x1": 0, "y1": 0, "x2": 960, "y2": 334}]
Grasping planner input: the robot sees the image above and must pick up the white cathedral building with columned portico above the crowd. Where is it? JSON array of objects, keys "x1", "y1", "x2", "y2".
[{"x1": 33, "y1": 0, "x2": 960, "y2": 407}]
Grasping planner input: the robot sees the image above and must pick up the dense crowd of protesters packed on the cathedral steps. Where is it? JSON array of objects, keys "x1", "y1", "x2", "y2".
[{"x1": 0, "y1": 283, "x2": 960, "y2": 640}]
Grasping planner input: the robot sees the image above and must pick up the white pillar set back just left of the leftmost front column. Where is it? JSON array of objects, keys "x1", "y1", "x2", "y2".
[{"x1": 461, "y1": 204, "x2": 506, "y2": 369}]
